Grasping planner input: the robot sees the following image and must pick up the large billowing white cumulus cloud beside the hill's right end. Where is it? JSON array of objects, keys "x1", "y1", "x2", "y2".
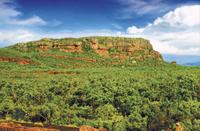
[{"x1": 127, "y1": 5, "x2": 200, "y2": 56}]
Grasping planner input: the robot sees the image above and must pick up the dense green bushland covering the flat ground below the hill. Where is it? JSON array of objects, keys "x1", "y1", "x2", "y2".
[{"x1": 0, "y1": 66, "x2": 200, "y2": 131}]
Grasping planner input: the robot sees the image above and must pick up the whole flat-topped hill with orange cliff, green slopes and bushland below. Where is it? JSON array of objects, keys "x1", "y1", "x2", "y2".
[{"x1": 0, "y1": 37, "x2": 200, "y2": 131}]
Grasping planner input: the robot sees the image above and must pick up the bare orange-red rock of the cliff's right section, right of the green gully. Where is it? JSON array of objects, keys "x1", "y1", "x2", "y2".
[{"x1": 89, "y1": 39, "x2": 162, "y2": 61}]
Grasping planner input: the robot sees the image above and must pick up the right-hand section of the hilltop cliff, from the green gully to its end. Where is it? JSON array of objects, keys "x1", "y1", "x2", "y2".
[{"x1": 88, "y1": 38, "x2": 163, "y2": 61}]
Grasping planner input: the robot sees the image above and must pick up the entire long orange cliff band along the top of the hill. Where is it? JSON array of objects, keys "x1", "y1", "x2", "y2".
[{"x1": 16, "y1": 37, "x2": 163, "y2": 61}]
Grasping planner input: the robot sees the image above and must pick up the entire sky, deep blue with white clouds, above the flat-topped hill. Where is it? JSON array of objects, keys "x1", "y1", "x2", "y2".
[{"x1": 0, "y1": 0, "x2": 200, "y2": 63}]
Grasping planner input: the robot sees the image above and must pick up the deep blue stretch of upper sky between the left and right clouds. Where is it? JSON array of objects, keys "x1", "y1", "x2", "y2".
[{"x1": 12, "y1": 0, "x2": 198, "y2": 31}]
